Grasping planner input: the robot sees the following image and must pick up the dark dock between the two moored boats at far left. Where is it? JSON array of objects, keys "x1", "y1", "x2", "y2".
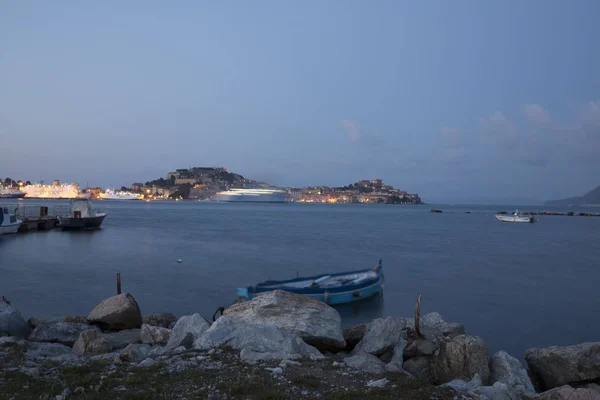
[{"x1": 2, "y1": 204, "x2": 70, "y2": 232}]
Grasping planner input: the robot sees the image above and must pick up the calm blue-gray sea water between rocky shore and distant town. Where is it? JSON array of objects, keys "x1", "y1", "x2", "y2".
[{"x1": 0, "y1": 201, "x2": 600, "y2": 358}]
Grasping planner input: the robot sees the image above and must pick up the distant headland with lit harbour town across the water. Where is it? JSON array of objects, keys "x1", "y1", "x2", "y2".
[{"x1": 4, "y1": 167, "x2": 423, "y2": 204}]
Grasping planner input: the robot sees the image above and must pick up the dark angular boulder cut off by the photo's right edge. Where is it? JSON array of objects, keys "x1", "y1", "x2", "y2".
[{"x1": 525, "y1": 342, "x2": 600, "y2": 390}]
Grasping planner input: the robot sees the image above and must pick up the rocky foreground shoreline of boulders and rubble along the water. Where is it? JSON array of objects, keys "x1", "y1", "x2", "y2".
[{"x1": 0, "y1": 291, "x2": 600, "y2": 400}]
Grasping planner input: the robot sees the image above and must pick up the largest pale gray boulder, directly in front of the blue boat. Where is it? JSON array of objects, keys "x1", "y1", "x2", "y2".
[{"x1": 223, "y1": 290, "x2": 346, "y2": 350}]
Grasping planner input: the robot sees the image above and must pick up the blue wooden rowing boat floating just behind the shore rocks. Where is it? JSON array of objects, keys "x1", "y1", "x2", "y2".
[{"x1": 237, "y1": 260, "x2": 383, "y2": 305}]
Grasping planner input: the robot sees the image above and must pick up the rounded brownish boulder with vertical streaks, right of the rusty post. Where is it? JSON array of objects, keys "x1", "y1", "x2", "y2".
[{"x1": 431, "y1": 335, "x2": 490, "y2": 384}]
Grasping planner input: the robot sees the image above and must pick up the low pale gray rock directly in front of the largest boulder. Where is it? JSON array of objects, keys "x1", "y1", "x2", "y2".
[{"x1": 194, "y1": 316, "x2": 322, "y2": 360}]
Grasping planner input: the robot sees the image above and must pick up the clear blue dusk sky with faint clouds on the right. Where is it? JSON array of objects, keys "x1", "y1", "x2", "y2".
[{"x1": 0, "y1": 0, "x2": 600, "y2": 201}]
